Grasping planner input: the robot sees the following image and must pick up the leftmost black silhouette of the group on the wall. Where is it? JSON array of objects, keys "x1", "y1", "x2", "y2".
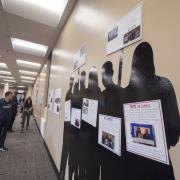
[{"x1": 60, "y1": 76, "x2": 74, "y2": 180}]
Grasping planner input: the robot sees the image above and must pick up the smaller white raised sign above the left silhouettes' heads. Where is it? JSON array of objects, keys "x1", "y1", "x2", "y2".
[{"x1": 73, "y1": 46, "x2": 86, "y2": 71}]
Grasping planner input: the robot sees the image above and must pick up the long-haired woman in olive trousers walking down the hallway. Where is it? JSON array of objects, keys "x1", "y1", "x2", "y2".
[{"x1": 21, "y1": 97, "x2": 33, "y2": 132}]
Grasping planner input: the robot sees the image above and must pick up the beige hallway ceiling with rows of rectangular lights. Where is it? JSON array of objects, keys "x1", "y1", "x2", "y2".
[{"x1": 0, "y1": 0, "x2": 77, "y2": 87}]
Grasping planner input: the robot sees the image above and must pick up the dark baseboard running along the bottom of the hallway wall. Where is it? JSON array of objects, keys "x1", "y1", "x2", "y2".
[{"x1": 33, "y1": 118, "x2": 60, "y2": 179}]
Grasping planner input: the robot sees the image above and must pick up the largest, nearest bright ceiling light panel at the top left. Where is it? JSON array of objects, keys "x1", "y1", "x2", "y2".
[{"x1": 1, "y1": 0, "x2": 68, "y2": 27}]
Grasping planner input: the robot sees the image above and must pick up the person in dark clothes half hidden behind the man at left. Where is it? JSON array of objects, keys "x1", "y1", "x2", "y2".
[{"x1": 9, "y1": 95, "x2": 18, "y2": 132}]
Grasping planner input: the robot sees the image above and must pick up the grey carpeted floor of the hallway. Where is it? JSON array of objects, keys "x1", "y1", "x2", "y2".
[{"x1": 0, "y1": 115, "x2": 57, "y2": 180}]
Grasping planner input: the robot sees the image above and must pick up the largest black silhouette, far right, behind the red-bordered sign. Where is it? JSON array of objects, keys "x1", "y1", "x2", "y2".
[{"x1": 125, "y1": 42, "x2": 180, "y2": 180}]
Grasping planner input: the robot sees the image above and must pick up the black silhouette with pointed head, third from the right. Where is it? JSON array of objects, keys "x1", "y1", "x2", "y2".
[{"x1": 79, "y1": 67, "x2": 101, "y2": 180}]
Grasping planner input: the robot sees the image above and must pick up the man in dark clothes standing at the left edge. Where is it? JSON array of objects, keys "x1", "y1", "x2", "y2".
[{"x1": 0, "y1": 91, "x2": 13, "y2": 151}]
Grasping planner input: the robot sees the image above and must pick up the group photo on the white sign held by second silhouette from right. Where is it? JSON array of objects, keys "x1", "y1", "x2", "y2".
[{"x1": 102, "y1": 131, "x2": 115, "y2": 150}]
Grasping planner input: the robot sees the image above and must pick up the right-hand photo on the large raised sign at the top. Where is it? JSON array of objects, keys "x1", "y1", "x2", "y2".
[{"x1": 124, "y1": 26, "x2": 141, "y2": 44}]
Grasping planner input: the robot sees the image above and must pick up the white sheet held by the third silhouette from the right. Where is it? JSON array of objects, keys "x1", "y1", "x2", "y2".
[{"x1": 82, "y1": 98, "x2": 98, "y2": 127}]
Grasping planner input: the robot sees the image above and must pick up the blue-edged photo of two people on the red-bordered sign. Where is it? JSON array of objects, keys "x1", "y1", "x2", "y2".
[{"x1": 131, "y1": 123, "x2": 156, "y2": 146}]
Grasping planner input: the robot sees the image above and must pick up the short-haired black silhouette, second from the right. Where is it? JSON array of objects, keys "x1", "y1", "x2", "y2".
[{"x1": 100, "y1": 61, "x2": 125, "y2": 180}]
